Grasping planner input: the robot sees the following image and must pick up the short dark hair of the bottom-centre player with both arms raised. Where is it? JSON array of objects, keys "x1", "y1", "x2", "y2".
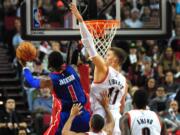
[{"x1": 91, "y1": 114, "x2": 105, "y2": 133}]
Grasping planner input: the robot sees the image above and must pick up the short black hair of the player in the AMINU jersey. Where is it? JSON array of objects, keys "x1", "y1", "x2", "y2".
[{"x1": 132, "y1": 90, "x2": 148, "y2": 109}]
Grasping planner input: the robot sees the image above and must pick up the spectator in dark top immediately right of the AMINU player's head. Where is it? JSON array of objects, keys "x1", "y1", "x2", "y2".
[{"x1": 149, "y1": 86, "x2": 168, "y2": 116}]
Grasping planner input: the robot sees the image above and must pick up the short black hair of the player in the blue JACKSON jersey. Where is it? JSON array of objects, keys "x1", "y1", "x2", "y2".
[{"x1": 48, "y1": 51, "x2": 64, "y2": 71}]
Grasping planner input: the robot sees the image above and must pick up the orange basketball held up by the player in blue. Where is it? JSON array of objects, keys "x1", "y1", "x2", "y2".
[{"x1": 16, "y1": 42, "x2": 37, "y2": 61}]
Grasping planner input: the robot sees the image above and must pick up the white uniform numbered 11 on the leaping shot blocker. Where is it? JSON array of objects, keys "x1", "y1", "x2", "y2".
[{"x1": 90, "y1": 67, "x2": 126, "y2": 135}]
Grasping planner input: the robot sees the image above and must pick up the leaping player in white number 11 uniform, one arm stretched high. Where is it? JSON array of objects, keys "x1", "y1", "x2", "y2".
[{"x1": 71, "y1": 4, "x2": 127, "y2": 135}]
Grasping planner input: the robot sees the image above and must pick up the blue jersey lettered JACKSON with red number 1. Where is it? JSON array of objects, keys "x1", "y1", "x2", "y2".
[{"x1": 49, "y1": 66, "x2": 86, "y2": 111}]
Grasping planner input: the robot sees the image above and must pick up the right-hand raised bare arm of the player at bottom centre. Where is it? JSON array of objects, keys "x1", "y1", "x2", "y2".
[{"x1": 98, "y1": 91, "x2": 115, "y2": 135}]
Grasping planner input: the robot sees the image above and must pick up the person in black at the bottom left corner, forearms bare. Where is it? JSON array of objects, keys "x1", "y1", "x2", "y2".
[{"x1": 0, "y1": 98, "x2": 27, "y2": 135}]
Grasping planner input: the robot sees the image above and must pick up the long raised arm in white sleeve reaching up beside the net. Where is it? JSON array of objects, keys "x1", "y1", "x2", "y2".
[{"x1": 70, "y1": 4, "x2": 108, "y2": 82}]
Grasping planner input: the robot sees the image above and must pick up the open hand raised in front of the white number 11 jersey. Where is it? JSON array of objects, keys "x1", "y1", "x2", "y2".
[{"x1": 97, "y1": 91, "x2": 109, "y2": 109}]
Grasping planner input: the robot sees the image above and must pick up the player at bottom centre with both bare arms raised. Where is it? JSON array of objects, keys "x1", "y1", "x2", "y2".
[{"x1": 62, "y1": 91, "x2": 115, "y2": 135}]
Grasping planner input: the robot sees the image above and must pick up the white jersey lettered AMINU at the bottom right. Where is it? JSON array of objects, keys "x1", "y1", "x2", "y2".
[{"x1": 128, "y1": 110, "x2": 161, "y2": 135}]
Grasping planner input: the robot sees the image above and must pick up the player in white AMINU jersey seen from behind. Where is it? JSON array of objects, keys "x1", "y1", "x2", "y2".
[{"x1": 120, "y1": 90, "x2": 166, "y2": 135}]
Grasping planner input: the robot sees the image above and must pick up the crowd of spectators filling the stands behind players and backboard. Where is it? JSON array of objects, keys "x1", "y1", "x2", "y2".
[{"x1": 0, "y1": 0, "x2": 180, "y2": 135}]
